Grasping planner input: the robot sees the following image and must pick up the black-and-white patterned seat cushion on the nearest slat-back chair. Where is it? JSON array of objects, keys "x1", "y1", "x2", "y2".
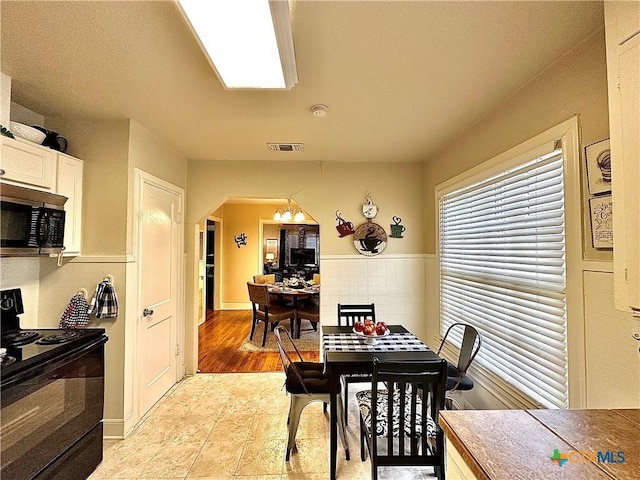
[{"x1": 356, "y1": 390, "x2": 437, "y2": 438}]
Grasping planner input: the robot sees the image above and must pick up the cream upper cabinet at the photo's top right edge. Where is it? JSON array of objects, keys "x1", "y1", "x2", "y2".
[{"x1": 604, "y1": 2, "x2": 640, "y2": 315}]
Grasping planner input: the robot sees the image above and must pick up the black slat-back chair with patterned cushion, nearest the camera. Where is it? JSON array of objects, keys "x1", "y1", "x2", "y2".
[{"x1": 356, "y1": 358, "x2": 447, "y2": 480}]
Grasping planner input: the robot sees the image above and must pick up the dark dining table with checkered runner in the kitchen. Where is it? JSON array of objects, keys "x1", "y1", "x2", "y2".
[{"x1": 322, "y1": 325, "x2": 440, "y2": 480}]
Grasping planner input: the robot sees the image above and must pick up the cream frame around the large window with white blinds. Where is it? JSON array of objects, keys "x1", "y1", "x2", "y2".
[{"x1": 435, "y1": 116, "x2": 586, "y2": 408}]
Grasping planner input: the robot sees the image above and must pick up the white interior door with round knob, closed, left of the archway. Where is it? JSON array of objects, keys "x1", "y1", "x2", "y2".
[{"x1": 137, "y1": 172, "x2": 183, "y2": 417}]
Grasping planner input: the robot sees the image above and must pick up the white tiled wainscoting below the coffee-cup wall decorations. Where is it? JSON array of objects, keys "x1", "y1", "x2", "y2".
[{"x1": 320, "y1": 254, "x2": 427, "y2": 341}]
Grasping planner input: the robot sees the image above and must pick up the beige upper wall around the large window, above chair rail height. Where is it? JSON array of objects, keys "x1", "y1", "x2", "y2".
[{"x1": 424, "y1": 30, "x2": 613, "y2": 261}]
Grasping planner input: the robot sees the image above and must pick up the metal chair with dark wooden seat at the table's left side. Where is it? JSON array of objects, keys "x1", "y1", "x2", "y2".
[{"x1": 273, "y1": 326, "x2": 349, "y2": 462}]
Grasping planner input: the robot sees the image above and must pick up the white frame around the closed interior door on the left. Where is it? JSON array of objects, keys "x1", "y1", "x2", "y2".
[{"x1": 130, "y1": 168, "x2": 186, "y2": 431}]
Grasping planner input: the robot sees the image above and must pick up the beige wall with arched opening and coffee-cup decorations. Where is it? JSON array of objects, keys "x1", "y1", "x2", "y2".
[{"x1": 185, "y1": 160, "x2": 425, "y2": 371}]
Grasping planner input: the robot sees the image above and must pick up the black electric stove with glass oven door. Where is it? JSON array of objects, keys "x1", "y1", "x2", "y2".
[{"x1": 0, "y1": 289, "x2": 107, "y2": 480}]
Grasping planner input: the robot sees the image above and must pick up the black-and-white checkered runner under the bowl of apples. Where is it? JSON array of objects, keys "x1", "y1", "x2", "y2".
[{"x1": 322, "y1": 333, "x2": 431, "y2": 352}]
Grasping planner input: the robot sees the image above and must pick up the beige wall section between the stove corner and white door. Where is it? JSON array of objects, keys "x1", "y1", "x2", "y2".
[{"x1": 32, "y1": 118, "x2": 187, "y2": 436}]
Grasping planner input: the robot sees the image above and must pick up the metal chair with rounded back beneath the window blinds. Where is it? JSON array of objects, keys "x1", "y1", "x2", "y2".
[{"x1": 437, "y1": 323, "x2": 482, "y2": 410}]
